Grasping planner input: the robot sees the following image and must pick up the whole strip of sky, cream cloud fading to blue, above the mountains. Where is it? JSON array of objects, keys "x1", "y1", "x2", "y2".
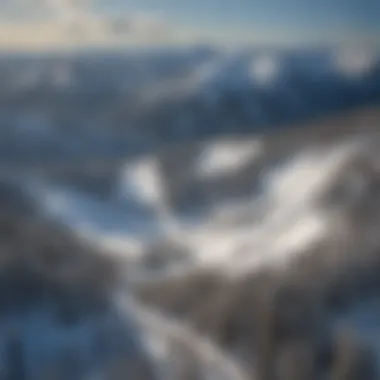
[{"x1": 0, "y1": 0, "x2": 380, "y2": 49}]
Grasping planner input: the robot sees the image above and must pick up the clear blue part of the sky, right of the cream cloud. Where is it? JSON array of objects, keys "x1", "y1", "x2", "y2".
[{"x1": 98, "y1": 0, "x2": 380, "y2": 42}]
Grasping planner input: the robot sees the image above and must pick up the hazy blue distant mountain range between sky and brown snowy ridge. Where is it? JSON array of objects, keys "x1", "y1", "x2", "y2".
[{"x1": 0, "y1": 46, "x2": 380, "y2": 165}]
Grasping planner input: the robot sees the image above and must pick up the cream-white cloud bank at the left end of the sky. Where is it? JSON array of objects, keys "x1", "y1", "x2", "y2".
[{"x1": 0, "y1": 0, "x2": 171, "y2": 45}]
